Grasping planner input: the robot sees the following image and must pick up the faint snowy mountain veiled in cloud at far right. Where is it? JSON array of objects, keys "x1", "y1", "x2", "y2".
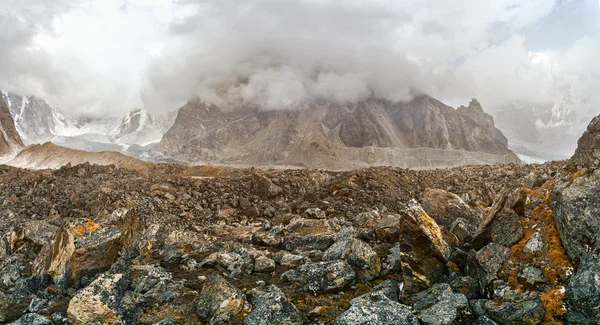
[{"x1": 494, "y1": 56, "x2": 600, "y2": 160}]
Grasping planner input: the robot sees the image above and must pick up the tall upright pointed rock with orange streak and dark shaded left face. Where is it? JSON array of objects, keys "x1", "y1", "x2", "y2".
[{"x1": 400, "y1": 200, "x2": 449, "y2": 294}]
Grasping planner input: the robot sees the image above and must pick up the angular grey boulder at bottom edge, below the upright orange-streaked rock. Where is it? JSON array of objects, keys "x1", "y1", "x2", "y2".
[{"x1": 407, "y1": 283, "x2": 472, "y2": 324}]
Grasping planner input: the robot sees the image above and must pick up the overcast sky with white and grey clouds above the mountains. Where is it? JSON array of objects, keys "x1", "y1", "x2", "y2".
[{"x1": 0, "y1": 0, "x2": 600, "y2": 116}]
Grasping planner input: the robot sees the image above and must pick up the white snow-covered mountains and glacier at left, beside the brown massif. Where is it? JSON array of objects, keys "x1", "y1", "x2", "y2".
[{"x1": 0, "y1": 92, "x2": 174, "y2": 151}]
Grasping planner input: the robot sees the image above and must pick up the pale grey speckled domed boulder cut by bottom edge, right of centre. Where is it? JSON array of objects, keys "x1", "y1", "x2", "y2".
[{"x1": 334, "y1": 296, "x2": 419, "y2": 325}]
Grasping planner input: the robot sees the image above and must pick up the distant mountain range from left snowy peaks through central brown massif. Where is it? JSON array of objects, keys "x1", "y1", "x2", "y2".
[{"x1": 1, "y1": 92, "x2": 519, "y2": 169}]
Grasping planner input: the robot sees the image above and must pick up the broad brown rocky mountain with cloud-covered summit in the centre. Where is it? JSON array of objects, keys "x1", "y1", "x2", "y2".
[{"x1": 160, "y1": 95, "x2": 519, "y2": 169}]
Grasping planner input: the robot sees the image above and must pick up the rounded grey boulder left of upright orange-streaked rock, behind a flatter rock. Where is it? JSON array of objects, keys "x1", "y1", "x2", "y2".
[{"x1": 322, "y1": 236, "x2": 381, "y2": 281}]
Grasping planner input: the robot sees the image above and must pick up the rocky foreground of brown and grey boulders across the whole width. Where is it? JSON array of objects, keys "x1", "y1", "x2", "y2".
[{"x1": 0, "y1": 153, "x2": 600, "y2": 325}]
